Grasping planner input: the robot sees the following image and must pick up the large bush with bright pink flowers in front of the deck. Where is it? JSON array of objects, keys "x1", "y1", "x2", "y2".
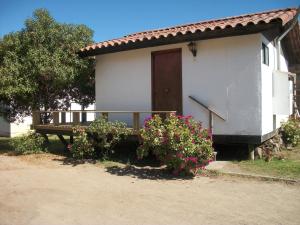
[{"x1": 137, "y1": 114, "x2": 213, "y2": 175}]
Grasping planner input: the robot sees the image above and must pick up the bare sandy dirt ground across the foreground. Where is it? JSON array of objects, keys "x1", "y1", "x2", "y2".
[{"x1": 0, "y1": 155, "x2": 300, "y2": 225}]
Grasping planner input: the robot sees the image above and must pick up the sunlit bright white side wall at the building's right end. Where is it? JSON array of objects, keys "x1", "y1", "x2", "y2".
[{"x1": 260, "y1": 35, "x2": 292, "y2": 135}]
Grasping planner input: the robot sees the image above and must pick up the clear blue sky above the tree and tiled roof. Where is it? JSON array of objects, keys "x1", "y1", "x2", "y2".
[{"x1": 0, "y1": 0, "x2": 300, "y2": 42}]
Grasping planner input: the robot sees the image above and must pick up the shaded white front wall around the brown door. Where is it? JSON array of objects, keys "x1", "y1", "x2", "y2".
[{"x1": 96, "y1": 34, "x2": 261, "y2": 135}]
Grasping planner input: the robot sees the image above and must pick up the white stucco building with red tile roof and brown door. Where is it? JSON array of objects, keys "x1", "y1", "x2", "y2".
[{"x1": 80, "y1": 8, "x2": 300, "y2": 144}]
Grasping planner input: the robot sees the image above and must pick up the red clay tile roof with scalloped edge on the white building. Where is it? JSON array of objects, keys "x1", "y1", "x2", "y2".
[{"x1": 80, "y1": 8, "x2": 297, "y2": 54}]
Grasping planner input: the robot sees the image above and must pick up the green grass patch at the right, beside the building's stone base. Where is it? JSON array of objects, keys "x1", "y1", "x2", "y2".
[{"x1": 237, "y1": 146, "x2": 300, "y2": 179}]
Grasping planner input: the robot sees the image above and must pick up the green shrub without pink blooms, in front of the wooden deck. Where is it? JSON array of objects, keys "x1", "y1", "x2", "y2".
[{"x1": 69, "y1": 117, "x2": 131, "y2": 159}]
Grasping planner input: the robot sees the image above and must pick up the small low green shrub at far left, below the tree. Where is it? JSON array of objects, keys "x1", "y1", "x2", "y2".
[{"x1": 10, "y1": 132, "x2": 47, "y2": 155}]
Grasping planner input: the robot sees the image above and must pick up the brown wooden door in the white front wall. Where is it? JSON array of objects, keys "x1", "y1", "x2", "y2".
[{"x1": 152, "y1": 49, "x2": 182, "y2": 114}]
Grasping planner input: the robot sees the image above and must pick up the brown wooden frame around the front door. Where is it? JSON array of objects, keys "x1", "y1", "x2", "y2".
[{"x1": 151, "y1": 48, "x2": 183, "y2": 115}]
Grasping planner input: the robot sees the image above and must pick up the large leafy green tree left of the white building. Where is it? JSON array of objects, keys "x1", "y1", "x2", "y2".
[{"x1": 0, "y1": 9, "x2": 95, "y2": 121}]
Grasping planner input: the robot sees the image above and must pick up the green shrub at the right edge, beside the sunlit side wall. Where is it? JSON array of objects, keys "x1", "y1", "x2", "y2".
[{"x1": 281, "y1": 119, "x2": 300, "y2": 147}]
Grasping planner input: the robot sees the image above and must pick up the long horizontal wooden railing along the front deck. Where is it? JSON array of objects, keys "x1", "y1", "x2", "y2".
[{"x1": 32, "y1": 110, "x2": 176, "y2": 130}]
